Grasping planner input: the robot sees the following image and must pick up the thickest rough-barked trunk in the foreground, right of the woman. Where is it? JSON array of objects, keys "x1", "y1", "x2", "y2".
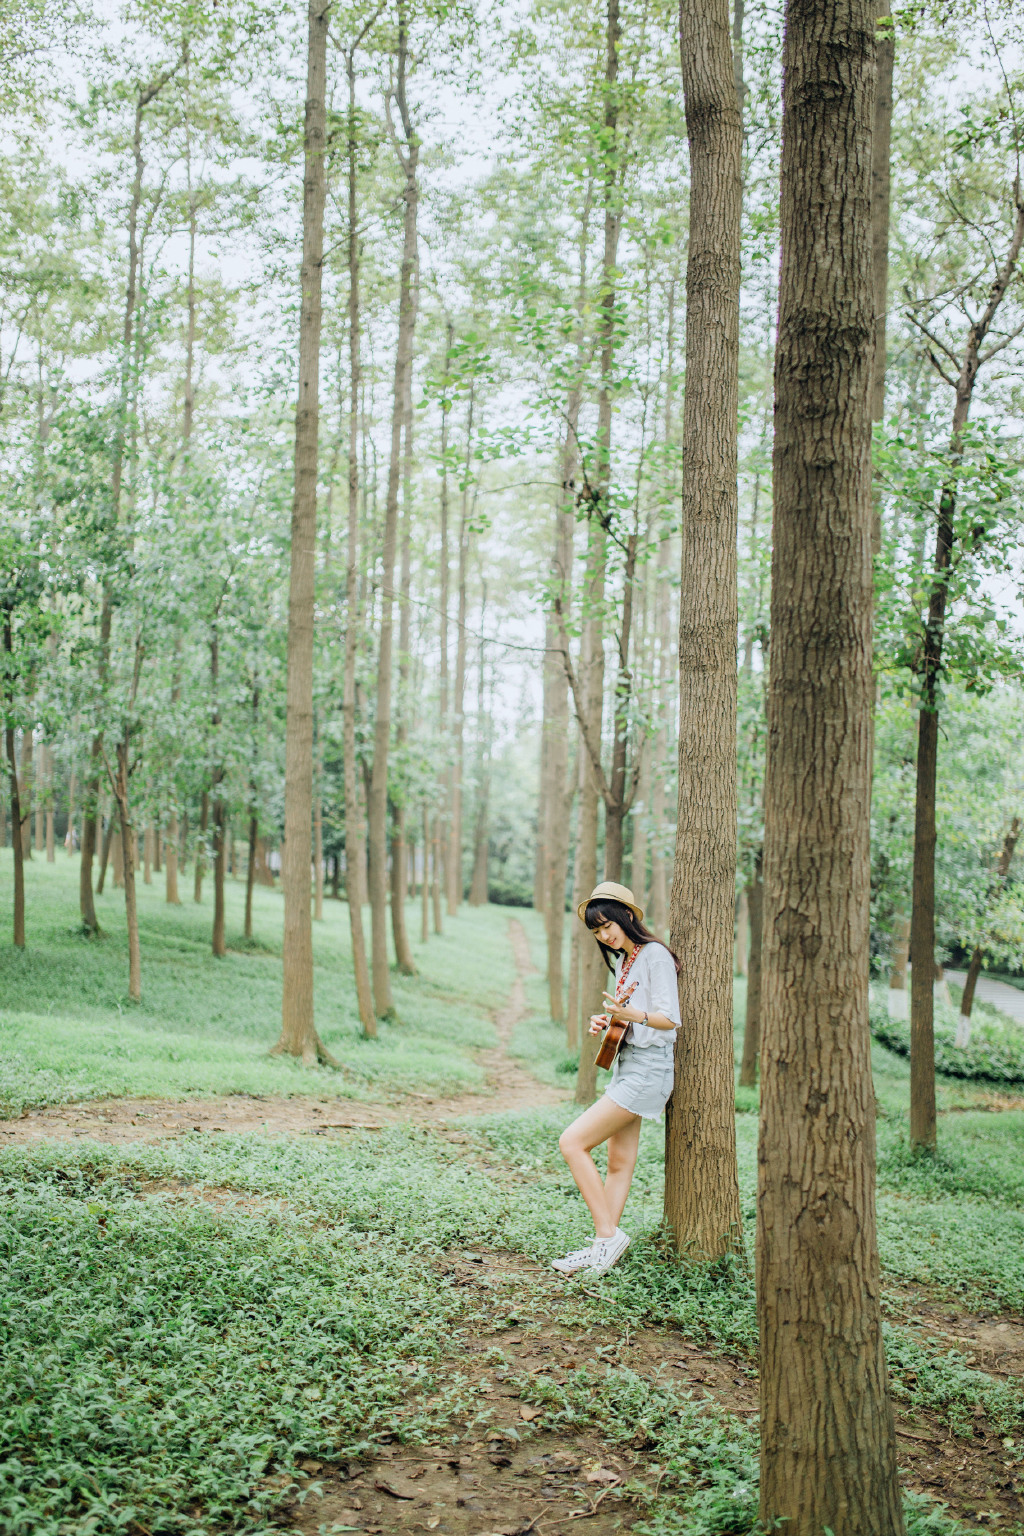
[{"x1": 757, "y1": 0, "x2": 904, "y2": 1536}]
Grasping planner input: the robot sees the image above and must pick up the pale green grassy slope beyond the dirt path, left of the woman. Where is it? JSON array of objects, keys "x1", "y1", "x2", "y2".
[{"x1": 0, "y1": 849, "x2": 550, "y2": 1117}]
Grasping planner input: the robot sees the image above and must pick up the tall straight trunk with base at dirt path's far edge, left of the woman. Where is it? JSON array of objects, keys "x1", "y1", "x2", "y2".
[{"x1": 273, "y1": 0, "x2": 335, "y2": 1066}]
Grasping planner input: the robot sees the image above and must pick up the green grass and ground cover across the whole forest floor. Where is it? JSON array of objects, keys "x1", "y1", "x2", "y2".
[{"x1": 0, "y1": 852, "x2": 1024, "y2": 1536}]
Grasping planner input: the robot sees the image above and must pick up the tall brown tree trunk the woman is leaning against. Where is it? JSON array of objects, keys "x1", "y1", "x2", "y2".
[{"x1": 665, "y1": 0, "x2": 743, "y2": 1258}]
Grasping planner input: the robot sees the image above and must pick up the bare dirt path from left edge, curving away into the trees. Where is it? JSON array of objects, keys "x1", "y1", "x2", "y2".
[{"x1": 0, "y1": 919, "x2": 568, "y2": 1146}]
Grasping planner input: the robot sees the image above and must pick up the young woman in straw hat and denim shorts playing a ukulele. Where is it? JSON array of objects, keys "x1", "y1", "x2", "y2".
[{"x1": 553, "y1": 880, "x2": 679, "y2": 1275}]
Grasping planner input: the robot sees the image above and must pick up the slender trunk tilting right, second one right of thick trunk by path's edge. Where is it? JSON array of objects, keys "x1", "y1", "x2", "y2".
[{"x1": 368, "y1": 9, "x2": 419, "y2": 1018}]
